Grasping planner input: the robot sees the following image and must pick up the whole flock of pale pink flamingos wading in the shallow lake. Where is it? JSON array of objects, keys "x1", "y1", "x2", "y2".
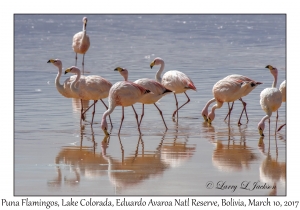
[{"x1": 48, "y1": 17, "x2": 286, "y2": 136}]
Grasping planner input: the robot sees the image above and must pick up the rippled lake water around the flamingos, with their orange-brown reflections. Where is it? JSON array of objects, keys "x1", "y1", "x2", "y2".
[{"x1": 14, "y1": 15, "x2": 286, "y2": 195}]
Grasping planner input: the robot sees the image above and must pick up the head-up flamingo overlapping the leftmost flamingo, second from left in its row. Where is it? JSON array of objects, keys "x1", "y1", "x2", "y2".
[{"x1": 65, "y1": 66, "x2": 112, "y2": 125}]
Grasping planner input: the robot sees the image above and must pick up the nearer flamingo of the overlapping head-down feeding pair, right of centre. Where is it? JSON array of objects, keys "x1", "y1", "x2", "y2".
[{"x1": 207, "y1": 77, "x2": 261, "y2": 125}]
